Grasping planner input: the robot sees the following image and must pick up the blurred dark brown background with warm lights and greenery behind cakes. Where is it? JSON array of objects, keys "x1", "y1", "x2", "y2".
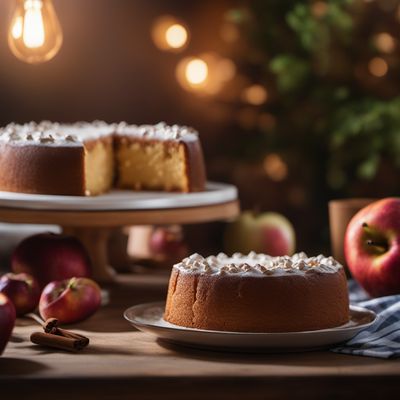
[{"x1": 0, "y1": 0, "x2": 400, "y2": 260}]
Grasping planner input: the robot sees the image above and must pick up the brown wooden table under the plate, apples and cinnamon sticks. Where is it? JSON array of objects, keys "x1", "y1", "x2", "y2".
[{"x1": 0, "y1": 274, "x2": 400, "y2": 400}]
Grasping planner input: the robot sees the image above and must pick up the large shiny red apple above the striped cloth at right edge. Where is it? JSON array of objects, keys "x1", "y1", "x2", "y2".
[{"x1": 344, "y1": 198, "x2": 400, "y2": 297}]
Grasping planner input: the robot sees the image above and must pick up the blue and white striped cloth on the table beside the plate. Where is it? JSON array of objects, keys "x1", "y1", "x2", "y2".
[{"x1": 331, "y1": 281, "x2": 400, "y2": 358}]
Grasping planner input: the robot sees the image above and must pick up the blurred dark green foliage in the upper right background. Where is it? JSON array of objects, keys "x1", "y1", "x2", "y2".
[{"x1": 247, "y1": 0, "x2": 400, "y2": 193}]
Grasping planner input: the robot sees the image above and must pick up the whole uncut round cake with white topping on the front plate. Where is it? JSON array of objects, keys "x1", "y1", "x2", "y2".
[{"x1": 164, "y1": 252, "x2": 349, "y2": 332}]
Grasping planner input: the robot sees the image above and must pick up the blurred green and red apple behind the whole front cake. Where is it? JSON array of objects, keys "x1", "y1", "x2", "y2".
[{"x1": 224, "y1": 211, "x2": 296, "y2": 256}]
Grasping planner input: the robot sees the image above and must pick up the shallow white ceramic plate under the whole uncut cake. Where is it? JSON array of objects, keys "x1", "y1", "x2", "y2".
[{"x1": 124, "y1": 302, "x2": 376, "y2": 352}]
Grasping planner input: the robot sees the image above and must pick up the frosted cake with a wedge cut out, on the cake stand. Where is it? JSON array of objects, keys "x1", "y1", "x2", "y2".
[{"x1": 0, "y1": 121, "x2": 206, "y2": 196}]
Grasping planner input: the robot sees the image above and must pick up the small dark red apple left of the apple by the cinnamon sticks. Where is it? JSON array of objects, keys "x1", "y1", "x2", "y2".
[{"x1": 0, "y1": 272, "x2": 40, "y2": 316}]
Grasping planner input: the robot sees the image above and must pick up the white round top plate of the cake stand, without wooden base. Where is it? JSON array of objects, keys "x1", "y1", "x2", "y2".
[{"x1": 0, "y1": 182, "x2": 237, "y2": 210}]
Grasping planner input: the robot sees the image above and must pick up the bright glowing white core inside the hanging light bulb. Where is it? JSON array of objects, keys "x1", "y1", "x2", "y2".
[{"x1": 23, "y1": 0, "x2": 44, "y2": 49}]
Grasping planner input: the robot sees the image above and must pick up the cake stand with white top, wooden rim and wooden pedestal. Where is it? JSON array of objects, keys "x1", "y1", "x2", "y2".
[{"x1": 0, "y1": 182, "x2": 239, "y2": 282}]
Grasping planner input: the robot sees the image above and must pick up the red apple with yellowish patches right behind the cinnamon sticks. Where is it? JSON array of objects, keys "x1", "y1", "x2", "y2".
[{"x1": 39, "y1": 277, "x2": 101, "y2": 324}]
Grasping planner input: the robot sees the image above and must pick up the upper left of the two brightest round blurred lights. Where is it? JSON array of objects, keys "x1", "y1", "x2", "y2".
[{"x1": 151, "y1": 15, "x2": 189, "y2": 52}]
